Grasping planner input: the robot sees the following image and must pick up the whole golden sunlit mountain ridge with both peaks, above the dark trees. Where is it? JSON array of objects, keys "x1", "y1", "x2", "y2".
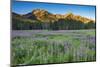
[{"x1": 23, "y1": 9, "x2": 94, "y2": 23}]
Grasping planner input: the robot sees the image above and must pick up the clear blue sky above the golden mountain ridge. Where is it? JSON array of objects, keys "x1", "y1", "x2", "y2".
[{"x1": 12, "y1": 1, "x2": 96, "y2": 20}]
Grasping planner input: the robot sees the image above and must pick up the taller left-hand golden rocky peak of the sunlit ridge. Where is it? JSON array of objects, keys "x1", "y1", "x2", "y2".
[{"x1": 23, "y1": 9, "x2": 56, "y2": 22}]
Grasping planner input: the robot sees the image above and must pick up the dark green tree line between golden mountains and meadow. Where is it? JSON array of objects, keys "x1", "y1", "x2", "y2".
[{"x1": 12, "y1": 18, "x2": 95, "y2": 30}]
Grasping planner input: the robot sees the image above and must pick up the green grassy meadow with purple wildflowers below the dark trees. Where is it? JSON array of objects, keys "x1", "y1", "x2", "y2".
[{"x1": 11, "y1": 30, "x2": 96, "y2": 65}]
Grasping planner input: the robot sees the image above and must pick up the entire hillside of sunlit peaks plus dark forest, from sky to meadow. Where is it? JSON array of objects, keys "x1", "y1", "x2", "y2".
[{"x1": 12, "y1": 9, "x2": 95, "y2": 30}]
